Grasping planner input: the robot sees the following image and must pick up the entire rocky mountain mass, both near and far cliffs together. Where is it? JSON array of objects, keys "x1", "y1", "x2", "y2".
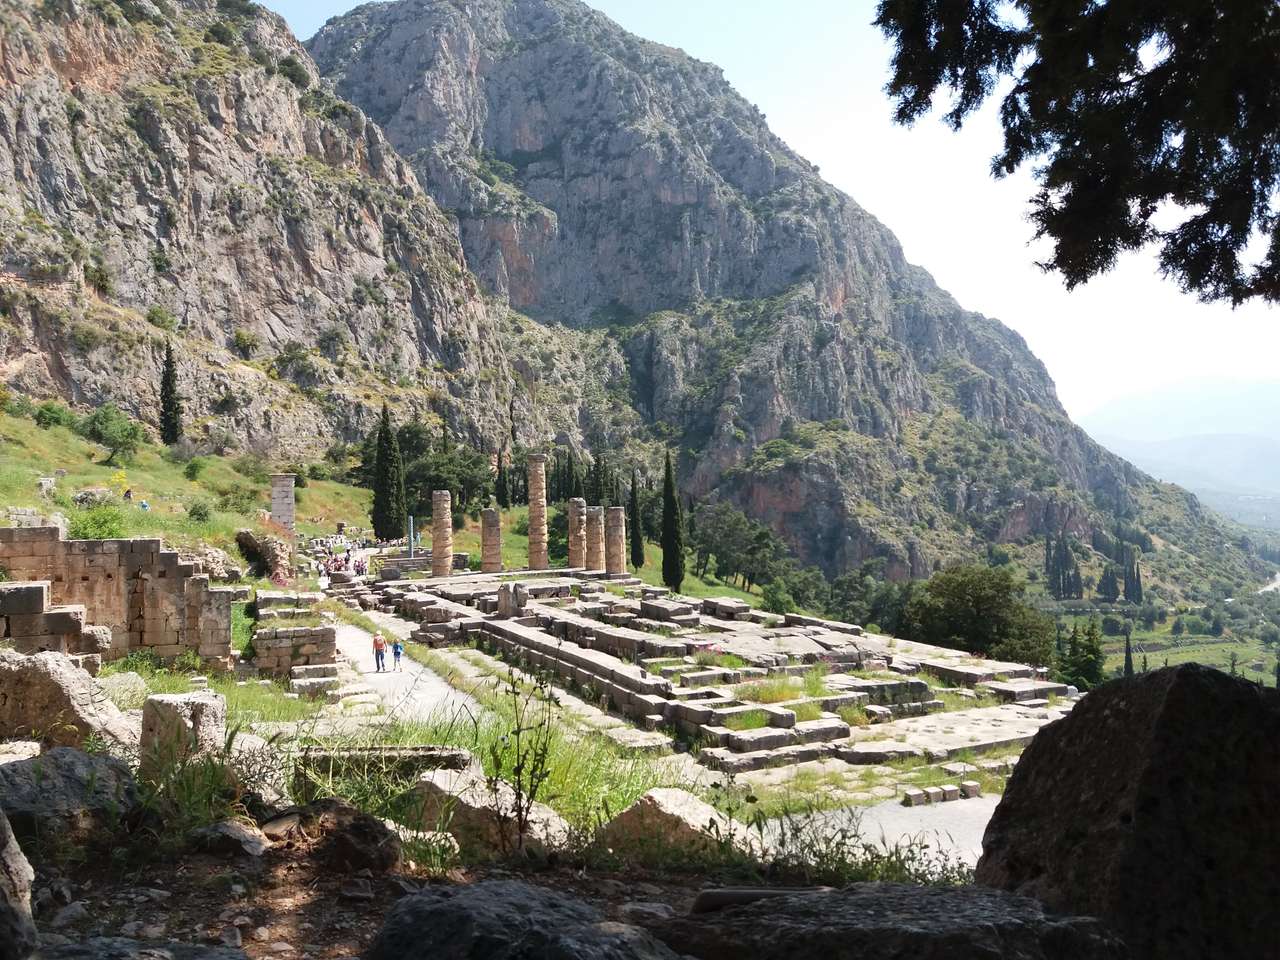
[{"x1": 0, "y1": 0, "x2": 1265, "y2": 593}]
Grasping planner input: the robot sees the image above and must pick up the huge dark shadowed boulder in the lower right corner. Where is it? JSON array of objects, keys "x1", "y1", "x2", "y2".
[{"x1": 977, "y1": 664, "x2": 1280, "y2": 960}]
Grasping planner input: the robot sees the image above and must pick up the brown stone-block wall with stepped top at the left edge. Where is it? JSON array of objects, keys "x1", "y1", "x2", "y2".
[{"x1": 0, "y1": 526, "x2": 234, "y2": 664}]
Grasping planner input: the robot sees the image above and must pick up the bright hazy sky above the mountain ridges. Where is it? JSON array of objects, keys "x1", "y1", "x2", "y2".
[{"x1": 264, "y1": 0, "x2": 1280, "y2": 416}]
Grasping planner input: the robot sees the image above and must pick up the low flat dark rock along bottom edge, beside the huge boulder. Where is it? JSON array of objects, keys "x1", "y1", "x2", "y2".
[{"x1": 648, "y1": 883, "x2": 1129, "y2": 960}]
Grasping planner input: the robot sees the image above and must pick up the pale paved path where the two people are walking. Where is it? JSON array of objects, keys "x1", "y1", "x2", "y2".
[{"x1": 338, "y1": 614, "x2": 483, "y2": 721}]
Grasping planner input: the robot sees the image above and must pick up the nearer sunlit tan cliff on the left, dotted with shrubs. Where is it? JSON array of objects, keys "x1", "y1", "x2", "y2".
[{"x1": 0, "y1": 0, "x2": 619, "y2": 453}]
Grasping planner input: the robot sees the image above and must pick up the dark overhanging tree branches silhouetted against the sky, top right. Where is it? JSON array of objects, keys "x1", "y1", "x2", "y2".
[{"x1": 876, "y1": 0, "x2": 1280, "y2": 303}]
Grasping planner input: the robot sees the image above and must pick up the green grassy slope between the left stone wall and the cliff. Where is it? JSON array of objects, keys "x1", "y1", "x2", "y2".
[{"x1": 0, "y1": 413, "x2": 370, "y2": 549}]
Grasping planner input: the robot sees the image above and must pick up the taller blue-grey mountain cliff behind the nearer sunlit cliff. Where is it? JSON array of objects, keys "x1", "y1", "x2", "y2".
[{"x1": 307, "y1": 0, "x2": 1239, "y2": 586}]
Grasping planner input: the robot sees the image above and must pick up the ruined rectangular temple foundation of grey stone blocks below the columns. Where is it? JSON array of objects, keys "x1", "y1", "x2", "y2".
[{"x1": 320, "y1": 570, "x2": 1074, "y2": 772}]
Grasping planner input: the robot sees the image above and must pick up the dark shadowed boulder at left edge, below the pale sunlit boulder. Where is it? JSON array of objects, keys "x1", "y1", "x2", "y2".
[{"x1": 0, "y1": 746, "x2": 138, "y2": 842}]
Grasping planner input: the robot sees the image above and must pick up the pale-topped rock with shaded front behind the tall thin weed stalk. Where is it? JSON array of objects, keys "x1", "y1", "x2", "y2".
[{"x1": 408, "y1": 767, "x2": 571, "y2": 858}]
